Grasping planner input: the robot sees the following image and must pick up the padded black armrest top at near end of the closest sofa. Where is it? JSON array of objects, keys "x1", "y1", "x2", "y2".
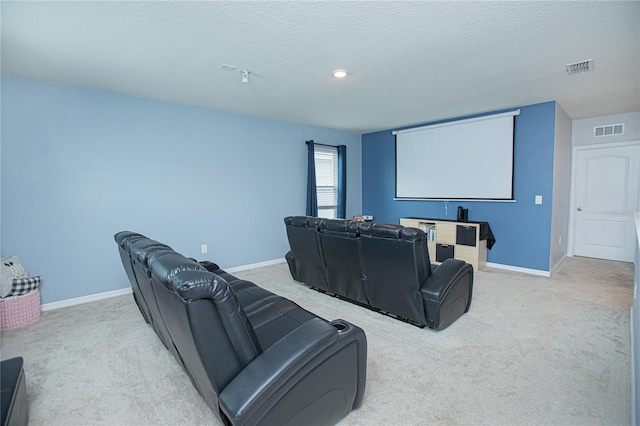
[{"x1": 219, "y1": 318, "x2": 338, "y2": 424}]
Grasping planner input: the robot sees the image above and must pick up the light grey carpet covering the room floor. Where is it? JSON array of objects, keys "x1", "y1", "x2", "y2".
[{"x1": 1, "y1": 257, "x2": 633, "y2": 425}]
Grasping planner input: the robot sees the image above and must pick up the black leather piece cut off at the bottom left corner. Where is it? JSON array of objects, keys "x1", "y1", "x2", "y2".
[{"x1": 0, "y1": 357, "x2": 29, "y2": 426}]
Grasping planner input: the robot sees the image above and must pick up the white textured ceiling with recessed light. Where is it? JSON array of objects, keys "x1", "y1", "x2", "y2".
[{"x1": 1, "y1": 0, "x2": 640, "y2": 133}]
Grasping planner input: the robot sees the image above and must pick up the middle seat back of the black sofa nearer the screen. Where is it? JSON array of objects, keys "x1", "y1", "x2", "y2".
[{"x1": 318, "y1": 219, "x2": 370, "y2": 305}]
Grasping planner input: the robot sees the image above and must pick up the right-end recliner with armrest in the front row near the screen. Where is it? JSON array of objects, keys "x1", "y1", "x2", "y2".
[{"x1": 359, "y1": 223, "x2": 473, "y2": 330}]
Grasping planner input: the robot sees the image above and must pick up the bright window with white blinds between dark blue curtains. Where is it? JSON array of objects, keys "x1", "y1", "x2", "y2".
[{"x1": 314, "y1": 145, "x2": 338, "y2": 219}]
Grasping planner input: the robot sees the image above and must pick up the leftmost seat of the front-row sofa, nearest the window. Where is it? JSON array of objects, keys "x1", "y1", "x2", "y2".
[{"x1": 284, "y1": 216, "x2": 329, "y2": 290}]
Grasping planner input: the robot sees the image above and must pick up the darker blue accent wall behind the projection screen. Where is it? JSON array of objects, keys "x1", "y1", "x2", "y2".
[{"x1": 362, "y1": 101, "x2": 555, "y2": 271}]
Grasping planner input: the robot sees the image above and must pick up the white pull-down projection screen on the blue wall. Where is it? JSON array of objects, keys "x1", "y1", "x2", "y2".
[{"x1": 394, "y1": 110, "x2": 520, "y2": 201}]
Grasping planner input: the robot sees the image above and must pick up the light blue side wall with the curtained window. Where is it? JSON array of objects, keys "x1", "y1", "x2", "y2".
[{"x1": 0, "y1": 75, "x2": 362, "y2": 303}]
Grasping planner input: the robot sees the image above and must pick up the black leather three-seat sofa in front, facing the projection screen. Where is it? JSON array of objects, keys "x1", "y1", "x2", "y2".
[{"x1": 284, "y1": 216, "x2": 473, "y2": 330}]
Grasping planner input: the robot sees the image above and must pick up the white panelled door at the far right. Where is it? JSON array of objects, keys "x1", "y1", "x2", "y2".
[{"x1": 574, "y1": 142, "x2": 640, "y2": 262}]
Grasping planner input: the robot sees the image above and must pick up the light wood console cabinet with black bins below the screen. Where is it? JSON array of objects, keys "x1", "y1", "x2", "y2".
[{"x1": 400, "y1": 217, "x2": 487, "y2": 271}]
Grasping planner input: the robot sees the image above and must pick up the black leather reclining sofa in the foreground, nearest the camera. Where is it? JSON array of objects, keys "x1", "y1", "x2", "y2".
[{"x1": 115, "y1": 231, "x2": 367, "y2": 425}]
